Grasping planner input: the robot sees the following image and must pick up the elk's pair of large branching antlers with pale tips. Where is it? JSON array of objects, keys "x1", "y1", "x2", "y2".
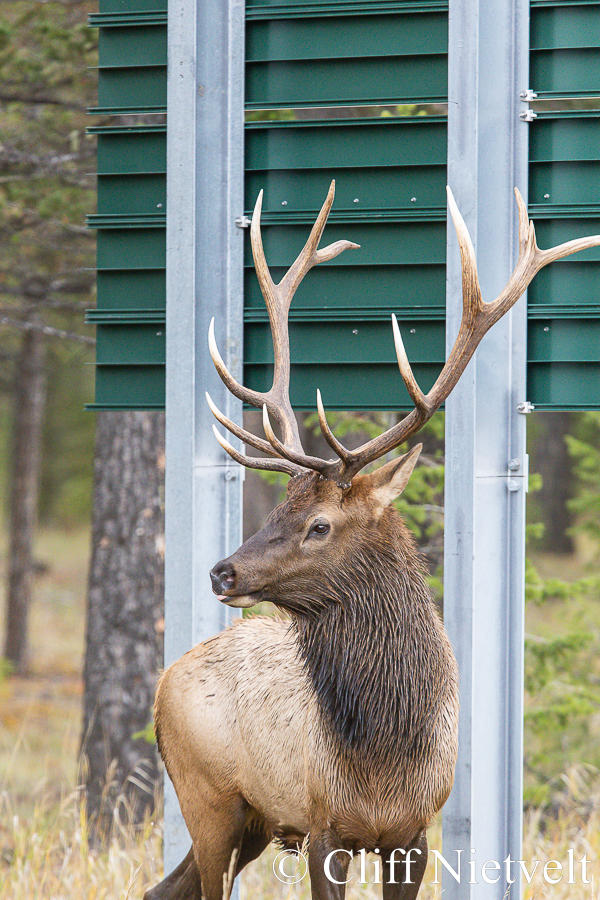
[{"x1": 209, "y1": 183, "x2": 600, "y2": 483}]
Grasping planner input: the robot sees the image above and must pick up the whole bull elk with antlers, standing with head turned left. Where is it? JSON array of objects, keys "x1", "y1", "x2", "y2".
[{"x1": 146, "y1": 183, "x2": 600, "y2": 900}]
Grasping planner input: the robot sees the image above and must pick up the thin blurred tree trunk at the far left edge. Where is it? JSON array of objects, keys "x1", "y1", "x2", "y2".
[{"x1": 4, "y1": 329, "x2": 46, "y2": 674}]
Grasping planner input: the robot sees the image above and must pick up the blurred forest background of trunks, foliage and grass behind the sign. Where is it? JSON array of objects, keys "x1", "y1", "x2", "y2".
[{"x1": 0, "y1": 0, "x2": 600, "y2": 900}]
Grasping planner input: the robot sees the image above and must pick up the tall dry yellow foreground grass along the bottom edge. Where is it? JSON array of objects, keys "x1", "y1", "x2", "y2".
[{"x1": 0, "y1": 791, "x2": 600, "y2": 900}]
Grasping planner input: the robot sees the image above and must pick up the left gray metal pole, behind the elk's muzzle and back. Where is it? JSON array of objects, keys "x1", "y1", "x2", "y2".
[{"x1": 164, "y1": 0, "x2": 245, "y2": 872}]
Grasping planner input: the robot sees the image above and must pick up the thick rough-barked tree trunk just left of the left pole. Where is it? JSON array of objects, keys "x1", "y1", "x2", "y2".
[{"x1": 82, "y1": 412, "x2": 165, "y2": 842}]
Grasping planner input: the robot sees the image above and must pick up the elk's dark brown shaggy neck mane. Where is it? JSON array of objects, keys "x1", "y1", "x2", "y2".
[{"x1": 293, "y1": 509, "x2": 447, "y2": 763}]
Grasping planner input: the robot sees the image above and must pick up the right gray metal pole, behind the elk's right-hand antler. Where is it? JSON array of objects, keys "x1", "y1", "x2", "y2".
[{"x1": 443, "y1": 0, "x2": 529, "y2": 900}]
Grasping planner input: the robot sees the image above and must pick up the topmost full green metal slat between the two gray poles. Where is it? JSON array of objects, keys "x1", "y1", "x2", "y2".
[{"x1": 246, "y1": 13, "x2": 448, "y2": 63}]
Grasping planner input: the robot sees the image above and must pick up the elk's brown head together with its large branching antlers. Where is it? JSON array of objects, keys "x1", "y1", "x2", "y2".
[{"x1": 207, "y1": 182, "x2": 600, "y2": 615}]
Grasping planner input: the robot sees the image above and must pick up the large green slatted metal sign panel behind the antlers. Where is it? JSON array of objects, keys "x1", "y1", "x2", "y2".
[{"x1": 88, "y1": 0, "x2": 600, "y2": 409}]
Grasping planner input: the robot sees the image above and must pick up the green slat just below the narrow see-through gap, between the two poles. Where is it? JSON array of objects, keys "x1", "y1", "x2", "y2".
[{"x1": 245, "y1": 116, "x2": 447, "y2": 171}]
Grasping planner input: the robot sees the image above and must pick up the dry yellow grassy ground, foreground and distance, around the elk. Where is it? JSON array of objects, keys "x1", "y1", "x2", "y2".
[{"x1": 0, "y1": 531, "x2": 600, "y2": 900}]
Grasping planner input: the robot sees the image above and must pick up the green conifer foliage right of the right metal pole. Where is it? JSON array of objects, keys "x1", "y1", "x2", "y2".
[{"x1": 525, "y1": 412, "x2": 600, "y2": 804}]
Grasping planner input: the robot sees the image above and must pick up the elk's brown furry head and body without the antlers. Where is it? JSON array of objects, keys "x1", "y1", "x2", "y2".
[{"x1": 147, "y1": 453, "x2": 458, "y2": 900}]
